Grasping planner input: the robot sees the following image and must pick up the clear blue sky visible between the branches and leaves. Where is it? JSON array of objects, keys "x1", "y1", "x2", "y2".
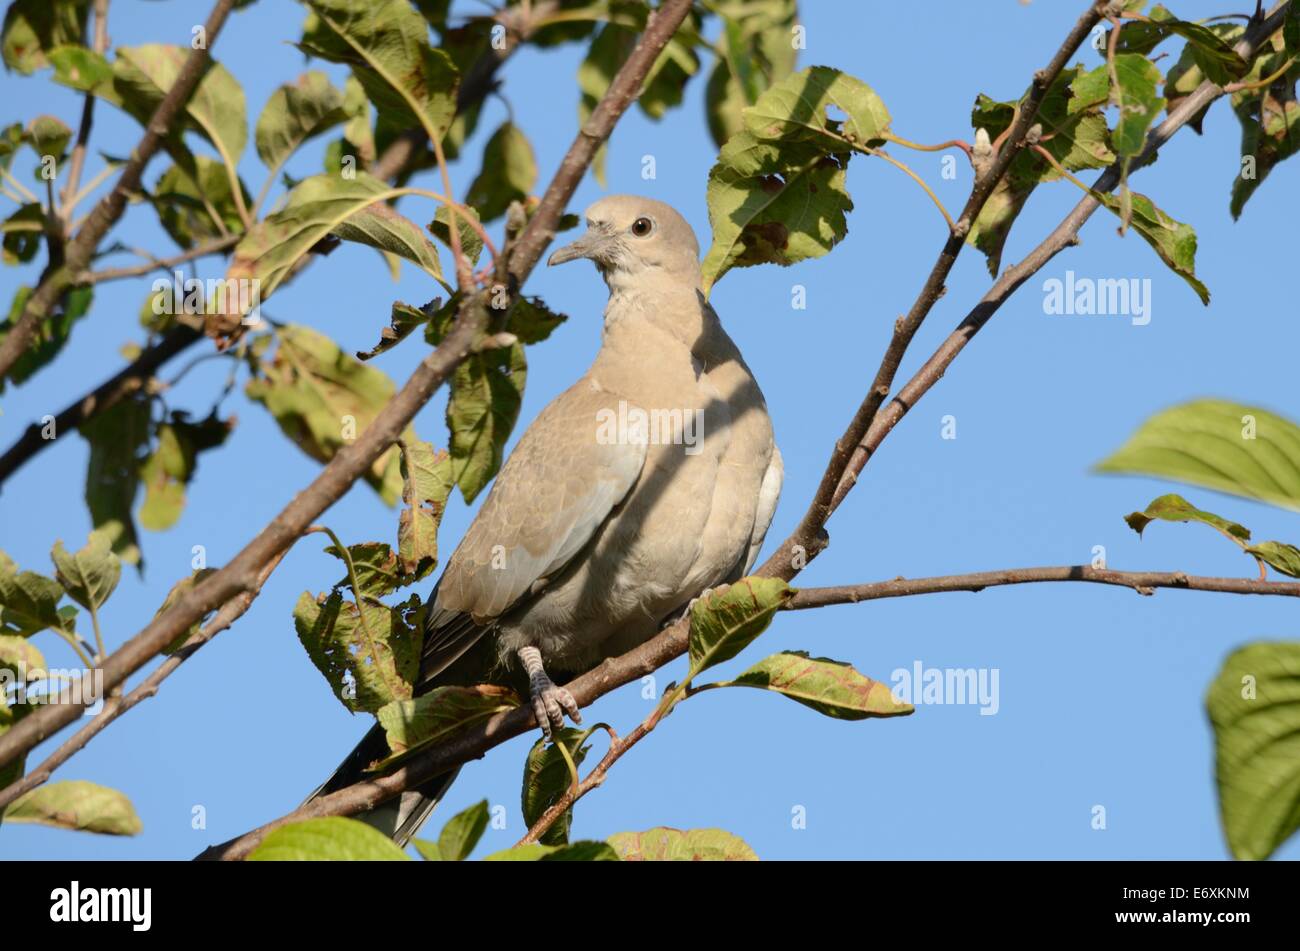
[{"x1": 0, "y1": 0, "x2": 1300, "y2": 859}]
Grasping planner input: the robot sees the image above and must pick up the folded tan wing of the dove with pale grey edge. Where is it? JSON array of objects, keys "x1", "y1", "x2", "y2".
[{"x1": 437, "y1": 378, "x2": 646, "y2": 622}]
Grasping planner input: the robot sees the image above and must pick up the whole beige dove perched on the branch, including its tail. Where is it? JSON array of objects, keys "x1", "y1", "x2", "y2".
[{"x1": 308, "y1": 195, "x2": 784, "y2": 846}]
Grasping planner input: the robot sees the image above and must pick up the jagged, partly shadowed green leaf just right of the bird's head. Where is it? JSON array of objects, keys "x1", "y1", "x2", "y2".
[{"x1": 702, "y1": 133, "x2": 853, "y2": 294}]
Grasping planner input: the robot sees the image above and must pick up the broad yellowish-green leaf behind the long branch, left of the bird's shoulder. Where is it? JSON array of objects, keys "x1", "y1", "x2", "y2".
[{"x1": 244, "y1": 323, "x2": 415, "y2": 505}]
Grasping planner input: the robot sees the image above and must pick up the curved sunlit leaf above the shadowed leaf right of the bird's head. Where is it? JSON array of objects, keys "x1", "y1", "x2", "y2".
[{"x1": 744, "y1": 66, "x2": 889, "y2": 152}]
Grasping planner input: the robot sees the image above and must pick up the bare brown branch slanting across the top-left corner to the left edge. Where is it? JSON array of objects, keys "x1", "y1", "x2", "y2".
[{"x1": 0, "y1": 0, "x2": 234, "y2": 378}]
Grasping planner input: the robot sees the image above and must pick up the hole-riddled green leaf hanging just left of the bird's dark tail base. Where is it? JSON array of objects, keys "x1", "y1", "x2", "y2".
[{"x1": 294, "y1": 591, "x2": 424, "y2": 713}]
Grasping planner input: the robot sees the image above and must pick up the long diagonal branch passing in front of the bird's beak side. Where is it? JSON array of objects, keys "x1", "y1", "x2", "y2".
[{"x1": 0, "y1": 0, "x2": 690, "y2": 795}]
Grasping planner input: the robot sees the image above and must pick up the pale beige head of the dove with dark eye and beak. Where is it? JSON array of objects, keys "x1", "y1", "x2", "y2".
[{"x1": 547, "y1": 195, "x2": 699, "y2": 287}]
